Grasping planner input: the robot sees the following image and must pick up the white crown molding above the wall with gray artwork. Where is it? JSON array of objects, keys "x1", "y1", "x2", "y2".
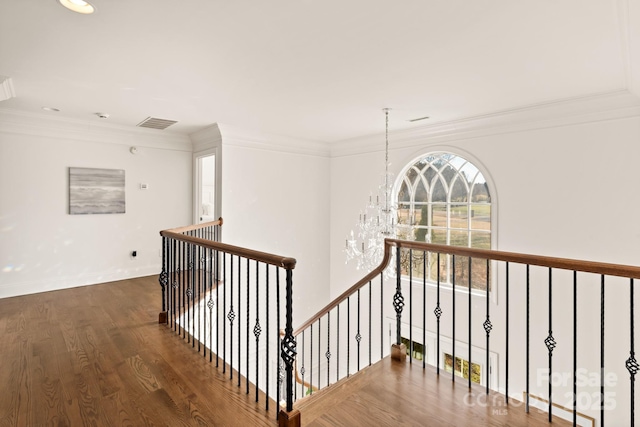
[{"x1": 0, "y1": 109, "x2": 193, "y2": 151}]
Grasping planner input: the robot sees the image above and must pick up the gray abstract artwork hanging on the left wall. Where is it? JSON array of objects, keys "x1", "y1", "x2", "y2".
[{"x1": 69, "y1": 168, "x2": 125, "y2": 215}]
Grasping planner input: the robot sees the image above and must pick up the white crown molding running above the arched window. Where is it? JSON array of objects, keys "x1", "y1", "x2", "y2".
[{"x1": 331, "y1": 90, "x2": 640, "y2": 157}]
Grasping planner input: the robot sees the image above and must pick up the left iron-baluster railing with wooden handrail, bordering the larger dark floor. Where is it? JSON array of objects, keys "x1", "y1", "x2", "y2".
[{"x1": 159, "y1": 219, "x2": 296, "y2": 422}]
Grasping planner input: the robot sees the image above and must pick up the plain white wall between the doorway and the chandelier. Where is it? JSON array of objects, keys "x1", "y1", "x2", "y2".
[{"x1": 221, "y1": 126, "x2": 330, "y2": 324}]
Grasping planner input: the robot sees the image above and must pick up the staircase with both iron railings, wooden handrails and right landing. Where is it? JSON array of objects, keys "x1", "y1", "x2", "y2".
[{"x1": 160, "y1": 220, "x2": 640, "y2": 426}]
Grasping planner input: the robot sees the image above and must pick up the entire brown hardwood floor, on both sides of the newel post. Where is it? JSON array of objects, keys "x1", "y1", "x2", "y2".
[{"x1": 0, "y1": 277, "x2": 569, "y2": 427}]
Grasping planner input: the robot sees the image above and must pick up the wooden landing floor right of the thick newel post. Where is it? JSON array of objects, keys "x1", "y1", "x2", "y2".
[{"x1": 296, "y1": 357, "x2": 571, "y2": 427}]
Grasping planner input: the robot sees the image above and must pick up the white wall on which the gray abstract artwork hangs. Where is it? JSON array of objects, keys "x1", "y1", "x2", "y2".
[{"x1": 0, "y1": 112, "x2": 192, "y2": 298}]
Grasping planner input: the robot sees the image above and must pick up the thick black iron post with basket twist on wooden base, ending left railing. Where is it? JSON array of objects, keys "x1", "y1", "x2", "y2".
[{"x1": 278, "y1": 268, "x2": 300, "y2": 427}]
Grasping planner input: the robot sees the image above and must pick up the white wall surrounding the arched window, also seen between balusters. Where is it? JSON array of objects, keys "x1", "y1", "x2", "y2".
[{"x1": 330, "y1": 94, "x2": 640, "y2": 425}]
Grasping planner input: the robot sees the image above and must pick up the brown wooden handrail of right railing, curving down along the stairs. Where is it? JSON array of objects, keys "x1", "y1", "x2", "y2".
[{"x1": 293, "y1": 239, "x2": 640, "y2": 336}]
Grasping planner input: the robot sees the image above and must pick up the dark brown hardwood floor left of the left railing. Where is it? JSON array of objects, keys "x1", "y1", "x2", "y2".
[{"x1": 0, "y1": 277, "x2": 276, "y2": 427}]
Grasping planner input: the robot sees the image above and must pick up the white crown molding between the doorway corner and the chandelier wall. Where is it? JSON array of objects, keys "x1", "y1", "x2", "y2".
[{"x1": 217, "y1": 123, "x2": 331, "y2": 157}]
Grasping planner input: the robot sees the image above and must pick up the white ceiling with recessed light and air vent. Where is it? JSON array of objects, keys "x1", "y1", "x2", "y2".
[{"x1": 0, "y1": 0, "x2": 640, "y2": 143}]
